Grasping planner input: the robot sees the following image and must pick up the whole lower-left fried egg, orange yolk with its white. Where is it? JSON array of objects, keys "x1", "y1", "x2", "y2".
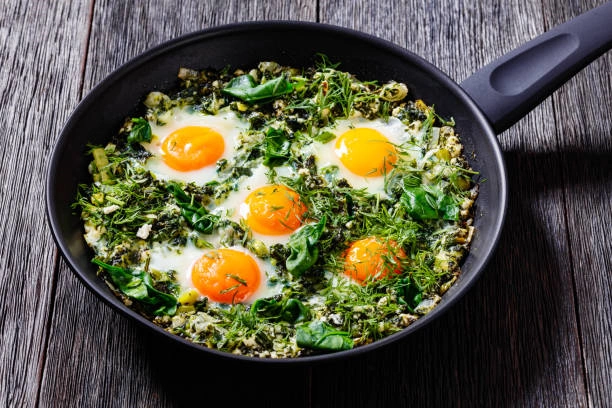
[{"x1": 149, "y1": 243, "x2": 283, "y2": 304}]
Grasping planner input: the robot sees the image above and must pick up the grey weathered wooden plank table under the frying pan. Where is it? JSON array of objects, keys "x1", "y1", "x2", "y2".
[{"x1": 0, "y1": 0, "x2": 612, "y2": 407}]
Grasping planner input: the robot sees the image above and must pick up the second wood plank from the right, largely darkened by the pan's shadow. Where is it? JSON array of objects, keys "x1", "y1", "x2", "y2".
[{"x1": 312, "y1": 0, "x2": 610, "y2": 407}]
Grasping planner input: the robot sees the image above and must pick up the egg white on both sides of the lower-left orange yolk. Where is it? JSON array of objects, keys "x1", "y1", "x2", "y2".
[{"x1": 149, "y1": 243, "x2": 283, "y2": 304}]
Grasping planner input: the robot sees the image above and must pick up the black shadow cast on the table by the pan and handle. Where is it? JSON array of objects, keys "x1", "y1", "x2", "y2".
[{"x1": 148, "y1": 146, "x2": 612, "y2": 407}]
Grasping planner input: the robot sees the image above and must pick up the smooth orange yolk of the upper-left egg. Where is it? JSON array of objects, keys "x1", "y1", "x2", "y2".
[{"x1": 161, "y1": 126, "x2": 225, "y2": 171}]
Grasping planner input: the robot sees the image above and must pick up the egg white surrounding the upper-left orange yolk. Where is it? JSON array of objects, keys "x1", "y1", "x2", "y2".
[{"x1": 142, "y1": 107, "x2": 249, "y2": 185}]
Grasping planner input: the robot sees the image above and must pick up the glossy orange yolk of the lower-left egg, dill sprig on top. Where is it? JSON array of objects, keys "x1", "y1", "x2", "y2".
[{"x1": 191, "y1": 248, "x2": 261, "y2": 304}]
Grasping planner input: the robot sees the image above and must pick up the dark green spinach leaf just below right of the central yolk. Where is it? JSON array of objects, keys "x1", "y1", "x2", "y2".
[{"x1": 285, "y1": 216, "x2": 327, "y2": 277}]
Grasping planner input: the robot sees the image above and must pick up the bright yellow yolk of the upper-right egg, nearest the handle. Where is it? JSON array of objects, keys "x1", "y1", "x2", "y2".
[{"x1": 335, "y1": 128, "x2": 397, "y2": 177}]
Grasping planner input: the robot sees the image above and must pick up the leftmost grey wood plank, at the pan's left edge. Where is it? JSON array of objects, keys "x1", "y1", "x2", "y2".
[{"x1": 0, "y1": 1, "x2": 88, "y2": 407}]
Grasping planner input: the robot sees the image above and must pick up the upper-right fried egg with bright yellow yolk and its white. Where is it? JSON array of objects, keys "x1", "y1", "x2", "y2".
[{"x1": 310, "y1": 117, "x2": 409, "y2": 195}]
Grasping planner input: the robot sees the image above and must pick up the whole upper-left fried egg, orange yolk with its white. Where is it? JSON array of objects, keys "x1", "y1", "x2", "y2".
[{"x1": 142, "y1": 107, "x2": 249, "y2": 184}]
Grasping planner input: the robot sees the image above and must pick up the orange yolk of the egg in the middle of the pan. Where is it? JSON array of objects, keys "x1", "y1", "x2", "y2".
[{"x1": 240, "y1": 185, "x2": 307, "y2": 235}]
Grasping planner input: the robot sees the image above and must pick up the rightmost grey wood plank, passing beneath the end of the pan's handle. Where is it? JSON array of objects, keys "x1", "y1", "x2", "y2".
[{"x1": 546, "y1": 1, "x2": 612, "y2": 407}]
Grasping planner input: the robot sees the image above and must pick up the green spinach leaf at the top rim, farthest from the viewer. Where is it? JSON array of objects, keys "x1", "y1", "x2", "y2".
[{"x1": 222, "y1": 74, "x2": 293, "y2": 103}]
